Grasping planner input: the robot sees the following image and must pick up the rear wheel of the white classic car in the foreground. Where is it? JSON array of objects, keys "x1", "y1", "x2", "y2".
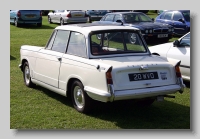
[{"x1": 71, "y1": 80, "x2": 92, "y2": 113}]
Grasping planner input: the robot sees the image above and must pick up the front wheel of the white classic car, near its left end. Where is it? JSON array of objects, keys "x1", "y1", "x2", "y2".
[{"x1": 23, "y1": 62, "x2": 35, "y2": 88}]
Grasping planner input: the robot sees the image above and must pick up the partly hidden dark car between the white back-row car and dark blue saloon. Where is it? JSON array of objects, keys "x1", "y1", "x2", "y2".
[{"x1": 86, "y1": 10, "x2": 110, "y2": 23}]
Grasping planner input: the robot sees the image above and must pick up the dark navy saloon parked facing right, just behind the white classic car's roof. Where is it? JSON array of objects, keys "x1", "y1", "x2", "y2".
[{"x1": 93, "y1": 12, "x2": 173, "y2": 42}]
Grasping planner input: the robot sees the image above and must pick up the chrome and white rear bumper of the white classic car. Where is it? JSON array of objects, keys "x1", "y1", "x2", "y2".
[{"x1": 84, "y1": 84, "x2": 184, "y2": 102}]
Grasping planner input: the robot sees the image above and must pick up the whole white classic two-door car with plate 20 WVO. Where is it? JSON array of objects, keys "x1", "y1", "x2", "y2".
[{"x1": 19, "y1": 23, "x2": 185, "y2": 113}]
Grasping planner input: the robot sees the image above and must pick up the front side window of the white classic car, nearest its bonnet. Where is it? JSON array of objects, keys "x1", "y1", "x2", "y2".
[{"x1": 52, "y1": 30, "x2": 70, "y2": 53}]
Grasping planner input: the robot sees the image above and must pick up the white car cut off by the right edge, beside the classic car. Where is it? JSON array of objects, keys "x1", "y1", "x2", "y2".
[{"x1": 149, "y1": 32, "x2": 190, "y2": 81}]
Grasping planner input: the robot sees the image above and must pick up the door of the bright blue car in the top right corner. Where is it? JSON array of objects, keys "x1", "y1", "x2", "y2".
[{"x1": 172, "y1": 12, "x2": 187, "y2": 34}]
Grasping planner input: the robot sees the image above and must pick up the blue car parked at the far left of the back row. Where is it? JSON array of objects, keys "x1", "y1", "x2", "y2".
[{"x1": 10, "y1": 10, "x2": 42, "y2": 27}]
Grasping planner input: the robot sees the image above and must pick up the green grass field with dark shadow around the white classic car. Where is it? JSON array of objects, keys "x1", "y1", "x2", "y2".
[{"x1": 10, "y1": 16, "x2": 190, "y2": 129}]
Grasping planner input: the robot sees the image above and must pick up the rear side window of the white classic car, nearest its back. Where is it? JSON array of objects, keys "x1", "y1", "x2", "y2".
[{"x1": 67, "y1": 32, "x2": 87, "y2": 57}]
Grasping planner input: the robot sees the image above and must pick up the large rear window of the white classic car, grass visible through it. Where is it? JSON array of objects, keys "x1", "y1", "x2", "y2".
[{"x1": 90, "y1": 31, "x2": 147, "y2": 55}]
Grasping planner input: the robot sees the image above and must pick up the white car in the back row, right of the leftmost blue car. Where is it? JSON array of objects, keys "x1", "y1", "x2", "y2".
[{"x1": 48, "y1": 10, "x2": 88, "y2": 25}]
